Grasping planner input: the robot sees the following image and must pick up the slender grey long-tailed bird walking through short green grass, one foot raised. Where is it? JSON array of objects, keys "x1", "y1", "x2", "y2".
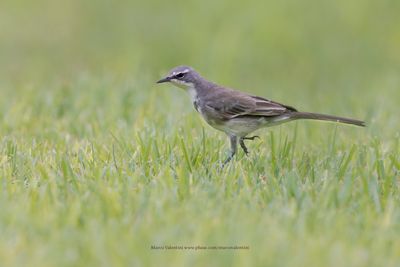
[{"x1": 157, "y1": 66, "x2": 365, "y2": 165}]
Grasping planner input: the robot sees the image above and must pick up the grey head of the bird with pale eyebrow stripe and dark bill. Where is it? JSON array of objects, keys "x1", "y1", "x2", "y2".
[{"x1": 157, "y1": 66, "x2": 200, "y2": 89}]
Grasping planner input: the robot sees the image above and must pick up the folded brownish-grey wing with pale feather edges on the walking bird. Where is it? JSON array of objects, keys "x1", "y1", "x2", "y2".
[{"x1": 204, "y1": 91, "x2": 295, "y2": 120}]
